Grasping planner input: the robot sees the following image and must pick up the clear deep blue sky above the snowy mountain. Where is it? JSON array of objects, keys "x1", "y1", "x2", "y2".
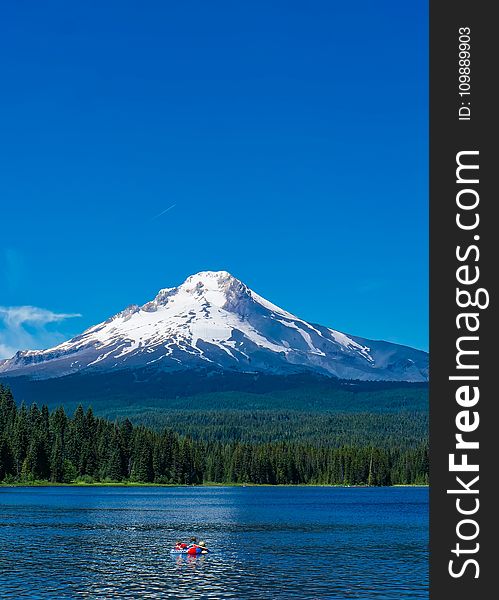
[{"x1": 0, "y1": 0, "x2": 428, "y2": 357}]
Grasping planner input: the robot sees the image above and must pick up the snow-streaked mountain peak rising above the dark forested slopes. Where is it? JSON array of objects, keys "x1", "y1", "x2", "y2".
[{"x1": 0, "y1": 271, "x2": 428, "y2": 381}]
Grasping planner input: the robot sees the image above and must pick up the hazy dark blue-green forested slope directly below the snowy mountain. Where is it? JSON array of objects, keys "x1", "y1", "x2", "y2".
[{"x1": 0, "y1": 369, "x2": 428, "y2": 418}]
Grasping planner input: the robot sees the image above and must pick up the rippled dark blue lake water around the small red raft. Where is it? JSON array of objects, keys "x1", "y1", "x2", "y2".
[{"x1": 0, "y1": 487, "x2": 428, "y2": 600}]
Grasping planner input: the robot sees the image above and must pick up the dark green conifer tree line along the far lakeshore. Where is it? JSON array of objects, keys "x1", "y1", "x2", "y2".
[{"x1": 0, "y1": 385, "x2": 428, "y2": 485}]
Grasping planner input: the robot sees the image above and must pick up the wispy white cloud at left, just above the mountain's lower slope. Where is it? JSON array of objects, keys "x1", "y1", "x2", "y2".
[{"x1": 0, "y1": 306, "x2": 81, "y2": 358}]
